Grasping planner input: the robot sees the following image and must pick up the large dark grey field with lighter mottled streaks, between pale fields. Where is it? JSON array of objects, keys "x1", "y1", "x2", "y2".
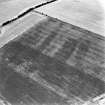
[{"x1": 0, "y1": 17, "x2": 105, "y2": 105}]
